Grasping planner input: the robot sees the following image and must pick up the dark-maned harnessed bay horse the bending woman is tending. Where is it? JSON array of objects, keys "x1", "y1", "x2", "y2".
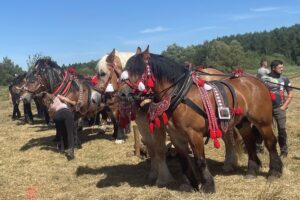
[{"x1": 24, "y1": 59, "x2": 104, "y2": 147}]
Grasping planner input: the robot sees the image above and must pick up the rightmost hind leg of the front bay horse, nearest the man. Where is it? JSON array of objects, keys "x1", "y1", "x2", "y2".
[{"x1": 258, "y1": 124, "x2": 283, "y2": 178}]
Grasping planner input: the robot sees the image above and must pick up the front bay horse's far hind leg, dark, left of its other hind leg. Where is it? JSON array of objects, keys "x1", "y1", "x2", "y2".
[{"x1": 238, "y1": 120, "x2": 261, "y2": 178}]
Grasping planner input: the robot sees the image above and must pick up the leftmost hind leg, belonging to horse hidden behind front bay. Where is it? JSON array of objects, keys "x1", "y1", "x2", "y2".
[{"x1": 222, "y1": 128, "x2": 238, "y2": 173}]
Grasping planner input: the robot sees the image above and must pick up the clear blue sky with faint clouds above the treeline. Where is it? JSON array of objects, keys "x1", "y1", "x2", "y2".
[{"x1": 0, "y1": 0, "x2": 300, "y2": 70}]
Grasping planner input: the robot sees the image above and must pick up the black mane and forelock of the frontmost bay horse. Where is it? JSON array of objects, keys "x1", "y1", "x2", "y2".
[{"x1": 125, "y1": 54, "x2": 188, "y2": 83}]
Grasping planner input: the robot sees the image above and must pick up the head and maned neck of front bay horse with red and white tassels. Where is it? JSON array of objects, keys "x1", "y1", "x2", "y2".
[{"x1": 119, "y1": 46, "x2": 188, "y2": 104}]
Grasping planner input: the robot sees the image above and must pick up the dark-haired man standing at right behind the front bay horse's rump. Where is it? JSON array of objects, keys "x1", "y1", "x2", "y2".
[{"x1": 262, "y1": 60, "x2": 293, "y2": 157}]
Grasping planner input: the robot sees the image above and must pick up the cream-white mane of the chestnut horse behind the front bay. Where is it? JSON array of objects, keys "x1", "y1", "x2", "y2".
[{"x1": 96, "y1": 51, "x2": 134, "y2": 73}]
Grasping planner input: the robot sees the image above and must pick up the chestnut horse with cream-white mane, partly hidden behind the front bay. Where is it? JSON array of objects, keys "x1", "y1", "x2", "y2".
[{"x1": 92, "y1": 49, "x2": 134, "y2": 144}]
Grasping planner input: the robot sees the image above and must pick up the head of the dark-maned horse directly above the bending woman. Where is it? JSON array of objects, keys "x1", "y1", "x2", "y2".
[{"x1": 24, "y1": 59, "x2": 64, "y2": 93}]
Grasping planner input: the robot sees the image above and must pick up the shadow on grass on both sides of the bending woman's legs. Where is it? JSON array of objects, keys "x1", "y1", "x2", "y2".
[{"x1": 20, "y1": 125, "x2": 112, "y2": 152}]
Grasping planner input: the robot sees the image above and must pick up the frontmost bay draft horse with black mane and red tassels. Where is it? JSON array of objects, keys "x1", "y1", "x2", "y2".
[{"x1": 119, "y1": 48, "x2": 283, "y2": 193}]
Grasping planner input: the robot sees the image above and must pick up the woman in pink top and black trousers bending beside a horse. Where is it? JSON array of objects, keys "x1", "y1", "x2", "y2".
[{"x1": 44, "y1": 95, "x2": 76, "y2": 160}]
